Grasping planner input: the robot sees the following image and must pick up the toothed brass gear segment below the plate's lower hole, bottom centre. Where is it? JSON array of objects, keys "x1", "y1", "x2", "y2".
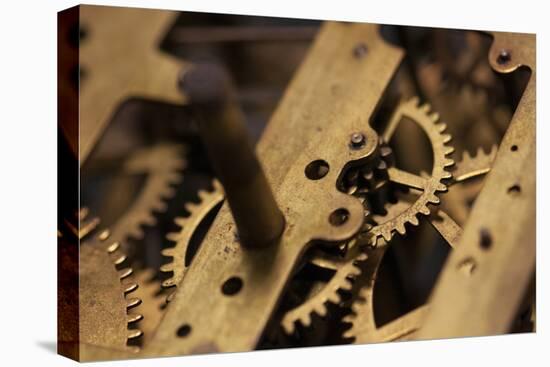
[{"x1": 281, "y1": 252, "x2": 367, "y2": 335}]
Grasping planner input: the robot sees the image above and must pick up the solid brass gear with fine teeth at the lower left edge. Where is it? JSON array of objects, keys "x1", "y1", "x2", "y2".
[{"x1": 79, "y1": 214, "x2": 143, "y2": 352}]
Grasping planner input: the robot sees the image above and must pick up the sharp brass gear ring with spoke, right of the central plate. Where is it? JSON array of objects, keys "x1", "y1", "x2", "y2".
[{"x1": 362, "y1": 98, "x2": 454, "y2": 246}]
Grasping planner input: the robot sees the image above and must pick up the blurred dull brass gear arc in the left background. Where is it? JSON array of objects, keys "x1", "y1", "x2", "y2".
[{"x1": 106, "y1": 144, "x2": 187, "y2": 241}]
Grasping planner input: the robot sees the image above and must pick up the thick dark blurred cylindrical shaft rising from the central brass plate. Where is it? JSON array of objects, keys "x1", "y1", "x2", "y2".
[{"x1": 182, "y1": 64, "x2": 284, "y2": 247}]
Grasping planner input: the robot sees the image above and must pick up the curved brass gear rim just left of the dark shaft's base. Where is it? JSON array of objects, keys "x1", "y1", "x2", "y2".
[{"x1": 160, "y1": 180, "x2": 224, "y2": 301}]
